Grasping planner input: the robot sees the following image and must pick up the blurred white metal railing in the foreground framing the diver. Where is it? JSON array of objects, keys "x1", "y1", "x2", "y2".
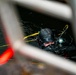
[{"x1": 0, "y1": 0, "x2": 76, "y2": 74}]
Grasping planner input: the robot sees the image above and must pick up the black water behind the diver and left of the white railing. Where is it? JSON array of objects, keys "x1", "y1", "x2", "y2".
[{"x1": 0, "y1": 5, "x2": 72, "y2": 54}]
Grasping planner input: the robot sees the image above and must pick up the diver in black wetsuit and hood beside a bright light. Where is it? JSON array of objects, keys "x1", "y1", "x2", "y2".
[{"x1": 37, "y1": 28, "x2": 76, "y2": 60}]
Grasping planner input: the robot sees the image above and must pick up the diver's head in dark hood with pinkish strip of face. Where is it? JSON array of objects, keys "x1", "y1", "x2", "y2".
[{"x1": 39, "y1": 28, "x2": 54, "y2": 47}]
